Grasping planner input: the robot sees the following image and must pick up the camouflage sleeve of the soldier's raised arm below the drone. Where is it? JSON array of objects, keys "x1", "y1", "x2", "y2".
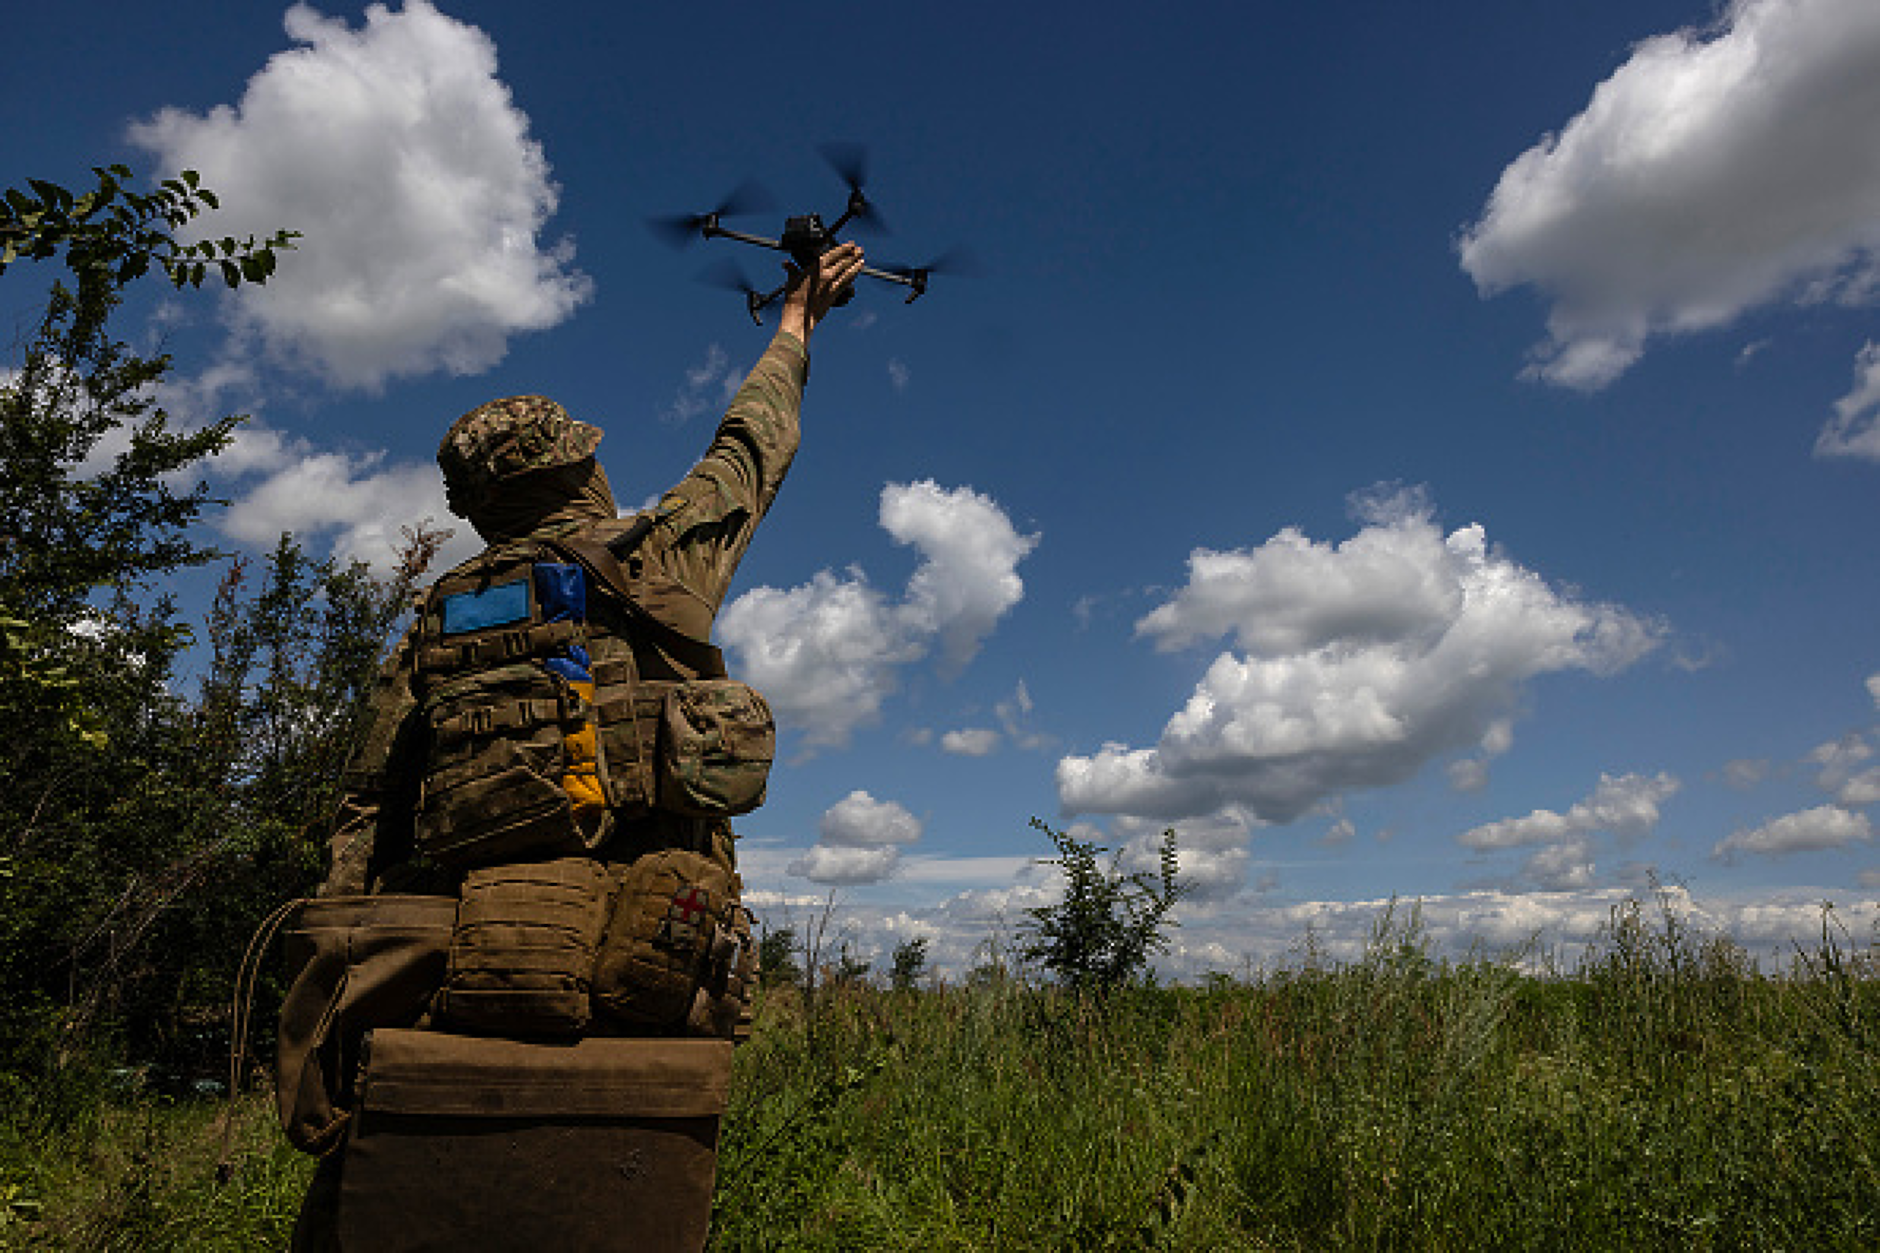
[{"x1": 647, "y1": 331, "x2": 808, "y2": 611}]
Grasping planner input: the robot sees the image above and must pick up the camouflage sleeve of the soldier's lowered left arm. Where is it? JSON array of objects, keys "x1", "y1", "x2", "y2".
[{"x1": 320, "y1": 625, "x2": 419, "y2": 896}]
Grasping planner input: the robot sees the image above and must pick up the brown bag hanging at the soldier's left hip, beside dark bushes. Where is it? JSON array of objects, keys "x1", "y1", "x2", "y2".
[{"x1": 274, "y1": 896, "x2": 457, "y2": 1153}]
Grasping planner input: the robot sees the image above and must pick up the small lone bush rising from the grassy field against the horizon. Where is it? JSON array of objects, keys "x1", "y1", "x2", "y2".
[{"x1": 1019, "y1": 818, "x2": 1184, "y2": 995}]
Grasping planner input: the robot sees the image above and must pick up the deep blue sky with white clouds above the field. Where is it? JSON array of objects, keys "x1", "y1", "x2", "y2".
[{"x1": 14, "y1": 0, "x2": 1880, "y2": 973}]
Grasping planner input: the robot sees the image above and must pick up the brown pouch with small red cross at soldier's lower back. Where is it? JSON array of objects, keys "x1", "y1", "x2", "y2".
[{"x1": 594, "y1": 849, "x2": 756, "y2": 1039}]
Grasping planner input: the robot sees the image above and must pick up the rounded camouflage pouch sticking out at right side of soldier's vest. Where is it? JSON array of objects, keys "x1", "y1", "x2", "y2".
[{"x1": 658, "y1": 679, "x2": 776, "y2": 818}]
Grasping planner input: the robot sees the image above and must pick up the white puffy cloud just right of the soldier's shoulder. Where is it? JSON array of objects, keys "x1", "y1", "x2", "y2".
[{"x1": 718, "y1": 482, "x2": 1038, "y2": 749}]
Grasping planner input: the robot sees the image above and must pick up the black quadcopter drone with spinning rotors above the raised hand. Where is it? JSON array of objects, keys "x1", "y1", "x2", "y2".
[{"x1": 650, "y1": 143, "x2": 963, "y2": 325}]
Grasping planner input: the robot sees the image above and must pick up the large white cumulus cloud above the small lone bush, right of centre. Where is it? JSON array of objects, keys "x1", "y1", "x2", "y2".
[{"x1": 1057, "y1": 495, "x2": 1664, "y2": 822}]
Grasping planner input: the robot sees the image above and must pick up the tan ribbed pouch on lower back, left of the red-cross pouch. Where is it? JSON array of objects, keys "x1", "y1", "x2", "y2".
[{"x1": 436, "y1": 858, "x2": 613, "y2": 1037}]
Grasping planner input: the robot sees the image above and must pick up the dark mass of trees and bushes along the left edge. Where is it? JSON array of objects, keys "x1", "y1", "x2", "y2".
[{"x1": 0, "y1": 166, "x2": 436, "y2": 1091}]
